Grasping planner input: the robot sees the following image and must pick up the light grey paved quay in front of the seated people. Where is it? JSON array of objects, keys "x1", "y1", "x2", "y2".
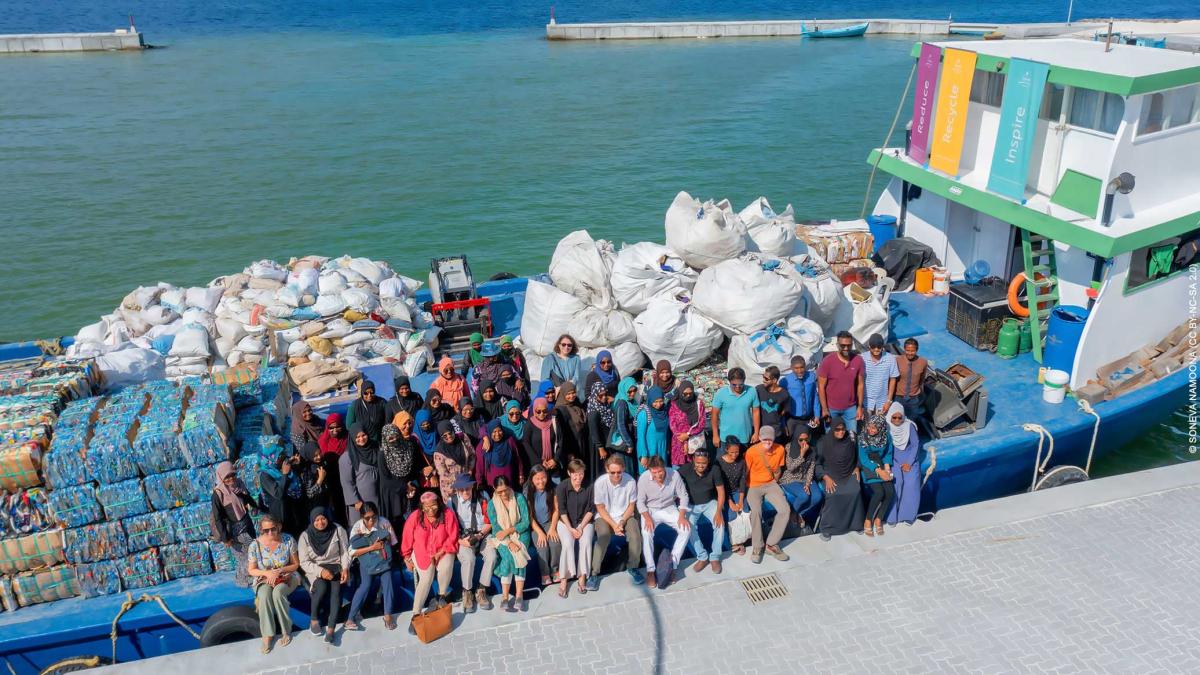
[{"x1": 108, "y1": 462, "x2": 1200, "y2": 675}]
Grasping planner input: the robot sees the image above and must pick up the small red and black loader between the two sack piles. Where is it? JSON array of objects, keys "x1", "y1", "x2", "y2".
[{"x1": 425, "y1": 255, "x2": 492, "y2": 374}]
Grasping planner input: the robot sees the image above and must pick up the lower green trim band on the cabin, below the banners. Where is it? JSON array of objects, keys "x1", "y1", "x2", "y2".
[{"x1": 868, "y1": 150, "x2": 1200, "y2": 258}]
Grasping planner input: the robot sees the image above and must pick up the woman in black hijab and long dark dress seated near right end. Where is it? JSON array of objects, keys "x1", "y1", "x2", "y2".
[{"x1": 812, "y1": 417, "x2": 863, "y2": 542}]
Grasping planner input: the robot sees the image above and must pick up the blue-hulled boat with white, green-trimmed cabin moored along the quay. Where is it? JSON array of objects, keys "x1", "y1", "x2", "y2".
[{"x1": 0, "y1": 40, "x2": 1200, "y2": 673}]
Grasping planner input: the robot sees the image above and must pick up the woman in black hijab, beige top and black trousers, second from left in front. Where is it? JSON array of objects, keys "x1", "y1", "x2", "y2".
[{"x1": 299, "y1": 508, "x2": 350, "y2": 644}]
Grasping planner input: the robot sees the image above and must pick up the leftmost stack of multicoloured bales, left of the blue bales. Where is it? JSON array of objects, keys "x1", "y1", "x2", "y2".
[{"x1": 0, "y1": 359, "x2": 97, "y2": 610}]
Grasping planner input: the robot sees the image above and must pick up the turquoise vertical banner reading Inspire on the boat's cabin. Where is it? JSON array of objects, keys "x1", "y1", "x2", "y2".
[{"x1": 988, "y1": 58, "x2": 1050, "y2": 202}]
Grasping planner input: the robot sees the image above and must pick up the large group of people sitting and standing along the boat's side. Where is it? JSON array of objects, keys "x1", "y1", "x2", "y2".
[{"x1": 212, "y1": 335, "x2": 924, "y2": 652}]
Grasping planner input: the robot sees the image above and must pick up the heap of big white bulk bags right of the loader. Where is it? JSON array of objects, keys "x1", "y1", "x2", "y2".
[{"x1": 521, "y1": 192, "x2": 890, "y2": 378}]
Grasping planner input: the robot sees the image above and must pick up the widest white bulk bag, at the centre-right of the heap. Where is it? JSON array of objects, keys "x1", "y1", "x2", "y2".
[{"x1": 691, "y1": 253, "x2": 804, "y2": 334}]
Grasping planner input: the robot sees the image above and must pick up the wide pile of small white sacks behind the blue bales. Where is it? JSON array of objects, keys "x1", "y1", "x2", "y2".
[{"x1": 71, "y1": 256, "x2": 439, "y2": 394}]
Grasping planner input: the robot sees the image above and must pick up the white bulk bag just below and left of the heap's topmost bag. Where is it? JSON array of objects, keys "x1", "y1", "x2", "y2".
[{"x1": 610, "y1": 241, "x2": 697, "y2": 315}]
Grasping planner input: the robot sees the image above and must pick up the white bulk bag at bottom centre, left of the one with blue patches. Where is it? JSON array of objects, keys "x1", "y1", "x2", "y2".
[{"x1": 634, "y1": 295, "x2": 724, "y2": 370}]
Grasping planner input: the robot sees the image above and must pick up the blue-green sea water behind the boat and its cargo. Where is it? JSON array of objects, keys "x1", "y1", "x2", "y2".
[{"x1": 0, "y1": 0, "x2": 1194, "y2": 471}]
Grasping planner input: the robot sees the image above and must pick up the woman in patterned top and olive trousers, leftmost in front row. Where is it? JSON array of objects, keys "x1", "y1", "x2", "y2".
[{"x1": 246, "y1": 514, "x2": 300, "y2": 653}]
